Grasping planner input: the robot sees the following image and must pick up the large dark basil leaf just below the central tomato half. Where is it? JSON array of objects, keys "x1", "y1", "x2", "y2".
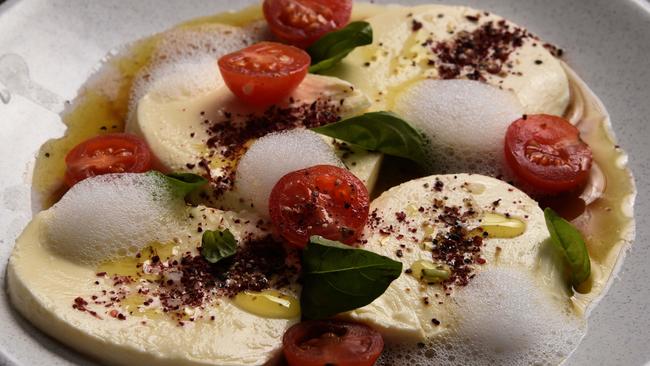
[{"x1": 300, "y1": 236, "x2": 402, "y2": 319}]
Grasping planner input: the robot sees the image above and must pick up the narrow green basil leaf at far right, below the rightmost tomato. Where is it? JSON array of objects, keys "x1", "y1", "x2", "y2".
[{"x1": 544, "y1": 208, "x2": 591, "y2": 287}]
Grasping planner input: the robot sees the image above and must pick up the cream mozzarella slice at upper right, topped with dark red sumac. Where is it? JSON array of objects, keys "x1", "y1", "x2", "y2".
[{"x1": 332, "y1": 5, "x2": 569, "y2": 115}]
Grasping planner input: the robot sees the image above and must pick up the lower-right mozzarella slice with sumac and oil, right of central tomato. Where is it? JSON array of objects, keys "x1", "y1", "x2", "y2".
[{"x1": 346, "y1": 174, "x2": 569, "y2": 343}]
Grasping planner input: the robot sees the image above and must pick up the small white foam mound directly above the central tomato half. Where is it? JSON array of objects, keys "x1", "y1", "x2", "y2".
[{"x1": 235, "y1": 129, "x2": 343, "y2": 215}]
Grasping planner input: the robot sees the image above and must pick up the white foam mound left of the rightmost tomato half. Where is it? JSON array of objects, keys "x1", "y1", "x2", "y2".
[{"x1": 396, "y1": 79, "x2": 523, "y2": 176}]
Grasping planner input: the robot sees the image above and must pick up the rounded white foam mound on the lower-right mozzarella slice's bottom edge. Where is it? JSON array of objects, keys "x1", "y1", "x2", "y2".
[{"x1": 450, "y1": 268, "x2": 582, "y2": 364}]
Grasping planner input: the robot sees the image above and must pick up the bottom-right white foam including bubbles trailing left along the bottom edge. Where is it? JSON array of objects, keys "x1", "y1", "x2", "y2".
[{"x1": 378, "y1": 268, "x2": 585, "y2": 366}]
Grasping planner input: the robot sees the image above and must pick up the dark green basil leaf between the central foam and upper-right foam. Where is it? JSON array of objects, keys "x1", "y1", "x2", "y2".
[{"x1": 313, "y1": 112, "x2": 427, "y2": 165}]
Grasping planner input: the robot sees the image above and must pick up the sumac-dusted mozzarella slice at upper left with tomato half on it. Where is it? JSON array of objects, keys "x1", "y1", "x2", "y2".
[{"x1": 127, "y1": 29, "x2": 381, "y2": 209}]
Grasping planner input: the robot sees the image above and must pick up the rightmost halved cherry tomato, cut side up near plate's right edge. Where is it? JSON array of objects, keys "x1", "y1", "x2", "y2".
[{"x1": 505, "y1": 114, "x2": 591, "y2": 194}]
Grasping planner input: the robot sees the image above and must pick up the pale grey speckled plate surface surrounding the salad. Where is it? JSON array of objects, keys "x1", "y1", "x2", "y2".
[{"x1": 0, "y1": 0, "x2": 650, "y2": 365}]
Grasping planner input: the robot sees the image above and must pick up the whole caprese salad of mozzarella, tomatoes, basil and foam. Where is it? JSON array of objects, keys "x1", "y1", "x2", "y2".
[{"x1": 8, "y1": 0, "x2": 634, "y2": 366}]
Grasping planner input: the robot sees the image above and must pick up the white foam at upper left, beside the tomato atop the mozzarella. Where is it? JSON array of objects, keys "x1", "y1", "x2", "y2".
[{"x1": 129, "y1": 23, "x2": 266, "y2": 124}]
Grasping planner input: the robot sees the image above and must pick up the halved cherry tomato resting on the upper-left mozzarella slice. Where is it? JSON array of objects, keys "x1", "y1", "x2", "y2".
[{"x1": 219, "y1": 42, "x2": 311, "y2": 106}]
